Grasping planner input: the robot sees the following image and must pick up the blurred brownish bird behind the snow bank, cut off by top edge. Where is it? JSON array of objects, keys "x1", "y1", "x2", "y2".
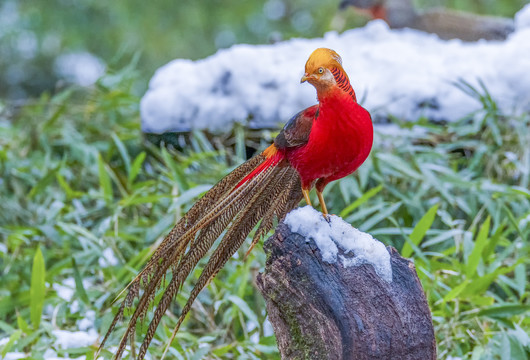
[{"x1": 340, "y1": 0, "x2": 515, "y2": 41}]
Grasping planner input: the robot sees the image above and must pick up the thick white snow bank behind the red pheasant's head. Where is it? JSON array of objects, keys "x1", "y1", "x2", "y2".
[{"x1": 141, "y1": 5, "x2": 530, "y2": 133}]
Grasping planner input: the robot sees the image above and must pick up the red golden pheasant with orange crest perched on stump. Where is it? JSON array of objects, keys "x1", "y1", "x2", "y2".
[{"x1": 95, "y1": 48, "x2": 373, "y2": 360}]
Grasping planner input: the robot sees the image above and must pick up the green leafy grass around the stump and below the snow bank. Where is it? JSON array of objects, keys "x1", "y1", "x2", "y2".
[{"x1": 0, "y1": 68, "x2": 530, "y2": 360}]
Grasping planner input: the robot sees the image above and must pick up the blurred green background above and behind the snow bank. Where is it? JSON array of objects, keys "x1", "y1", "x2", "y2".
[{"x1": 0, "y1": 0, "x2": 527, "y2": 99}]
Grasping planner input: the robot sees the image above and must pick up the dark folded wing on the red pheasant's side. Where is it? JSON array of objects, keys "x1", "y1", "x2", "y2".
[{"x1": 274, "y1": 105, "x2": 318, "y2": 149}]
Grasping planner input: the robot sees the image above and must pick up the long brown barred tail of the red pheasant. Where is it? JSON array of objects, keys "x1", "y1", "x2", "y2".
[{"x1": 98, "y1": 148, "x2": 302, "y2": 359}]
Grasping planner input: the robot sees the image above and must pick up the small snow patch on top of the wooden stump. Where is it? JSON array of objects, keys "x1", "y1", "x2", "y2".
[{"x1": 284, "y1": 206, "x2": 392, "y2": 282}]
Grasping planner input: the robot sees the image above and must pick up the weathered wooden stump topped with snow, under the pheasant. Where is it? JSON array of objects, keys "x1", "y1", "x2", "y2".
[{"x1": 257, "y1": 207, "x2": 436, "y2": 360}]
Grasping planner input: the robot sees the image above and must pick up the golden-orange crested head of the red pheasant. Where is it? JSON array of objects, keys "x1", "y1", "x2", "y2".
[{"x1": 300, "y1": 48, "x2": 349, "y2": 92}]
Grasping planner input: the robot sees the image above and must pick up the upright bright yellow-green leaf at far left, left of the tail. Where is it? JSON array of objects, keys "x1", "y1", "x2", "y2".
[{"x1": 30, "y1": 247, "x2": 46, "y2": 330}]
